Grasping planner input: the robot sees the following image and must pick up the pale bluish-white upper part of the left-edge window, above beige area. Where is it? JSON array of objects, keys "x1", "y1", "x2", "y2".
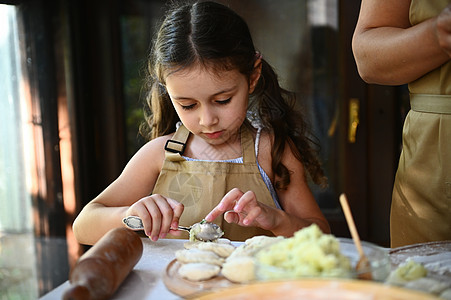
[{"x1": 0, "y1": 5, "x2": 32, "y2": 232}]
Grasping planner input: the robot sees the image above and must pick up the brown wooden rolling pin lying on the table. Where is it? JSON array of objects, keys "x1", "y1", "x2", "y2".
[{"x1": 63, "y1": 228, "x2": 143, "y2": 300}]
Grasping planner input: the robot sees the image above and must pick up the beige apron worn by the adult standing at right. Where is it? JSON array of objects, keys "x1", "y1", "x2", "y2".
[{"x1": 390, "y1": 0, "x2": 451, "y2": 247}]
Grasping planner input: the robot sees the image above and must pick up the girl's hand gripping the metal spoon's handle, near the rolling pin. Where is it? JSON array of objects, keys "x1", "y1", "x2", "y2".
[{"x1": 125, "y1": 194, "x2": 184, "y2": 241}]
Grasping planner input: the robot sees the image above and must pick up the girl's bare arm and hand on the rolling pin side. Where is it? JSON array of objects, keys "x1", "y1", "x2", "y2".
[{"x1": 73, "y1": 137, "x2": 183, "y2": 244}]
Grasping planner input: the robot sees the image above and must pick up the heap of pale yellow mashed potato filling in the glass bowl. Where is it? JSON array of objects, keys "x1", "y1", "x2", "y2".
[{"x1": 256, "y1": 224, "x2": 352, "y2": 279}]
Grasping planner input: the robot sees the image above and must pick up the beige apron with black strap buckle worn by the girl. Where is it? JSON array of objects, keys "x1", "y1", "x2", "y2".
[{"x1": 152, "y1": 125, "x2": 276, "y2": 241}]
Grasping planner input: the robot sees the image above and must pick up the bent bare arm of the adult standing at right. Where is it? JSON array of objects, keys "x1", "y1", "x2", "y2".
[{"x1": 352, "y1": 0, "x2": 451, "y2": 85}]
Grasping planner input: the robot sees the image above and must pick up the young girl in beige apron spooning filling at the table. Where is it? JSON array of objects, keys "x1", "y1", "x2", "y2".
[{"x1": 73, "y1": 2, "x2": 330, "y2": 244}]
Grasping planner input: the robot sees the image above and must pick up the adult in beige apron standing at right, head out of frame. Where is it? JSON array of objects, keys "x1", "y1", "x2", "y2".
[{"x1": 352, "y1": 0, "x2": 451, "y2": 247}]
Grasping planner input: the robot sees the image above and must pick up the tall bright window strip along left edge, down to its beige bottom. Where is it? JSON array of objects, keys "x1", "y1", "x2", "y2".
[{"x1": 0, "y1": 5, "x2": 38, "y2": 299}]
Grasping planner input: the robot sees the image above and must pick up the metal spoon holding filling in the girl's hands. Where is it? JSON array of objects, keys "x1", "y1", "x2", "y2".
[{"x1": 122, "y1": 216, "x2": 224, "y2": 242}]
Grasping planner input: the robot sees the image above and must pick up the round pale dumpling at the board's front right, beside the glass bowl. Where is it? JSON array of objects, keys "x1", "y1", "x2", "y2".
[{"x1": 221, "y1": 256, "x2": 255, "y2": 283}]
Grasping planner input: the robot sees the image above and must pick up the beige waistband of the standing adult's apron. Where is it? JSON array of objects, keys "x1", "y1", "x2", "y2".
[{"x1": 410, "y1": 94, "x2": 451, "y2": 114}]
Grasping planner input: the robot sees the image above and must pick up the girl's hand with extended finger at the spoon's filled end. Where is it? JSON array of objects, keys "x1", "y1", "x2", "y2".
[{"x1": 205, "y1": 188, "x2": 276, "y2": 230}]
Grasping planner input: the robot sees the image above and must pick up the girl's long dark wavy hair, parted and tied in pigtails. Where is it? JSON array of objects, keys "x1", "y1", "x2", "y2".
[{"x1": 140, "y1": 2, "x2": 327, "y2": 189}]
